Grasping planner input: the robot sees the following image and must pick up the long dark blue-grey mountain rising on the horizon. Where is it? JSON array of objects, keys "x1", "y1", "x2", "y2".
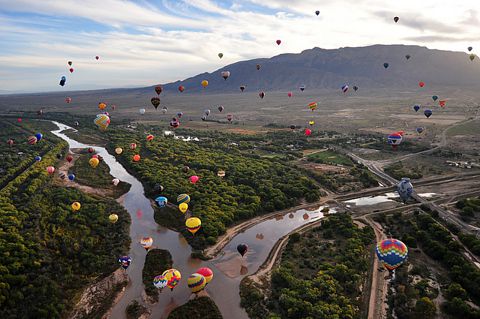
[{"x1": 154, "y1": 45, "x2": 480, "y2": 93}]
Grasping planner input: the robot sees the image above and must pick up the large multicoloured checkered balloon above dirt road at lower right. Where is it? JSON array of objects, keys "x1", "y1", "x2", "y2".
[{"x1": 375, "y1": 238, "x2": 408, "y2": 271}]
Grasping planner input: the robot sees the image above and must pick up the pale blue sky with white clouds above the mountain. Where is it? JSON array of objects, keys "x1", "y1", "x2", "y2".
[{"x1": 0, "y1": 0, "x2": 480, "y2": 94}]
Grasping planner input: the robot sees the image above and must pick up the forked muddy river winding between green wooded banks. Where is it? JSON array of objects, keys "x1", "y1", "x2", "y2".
[{"x1": 52, "y1": 121, "x2": 334, "y2": 319}]
